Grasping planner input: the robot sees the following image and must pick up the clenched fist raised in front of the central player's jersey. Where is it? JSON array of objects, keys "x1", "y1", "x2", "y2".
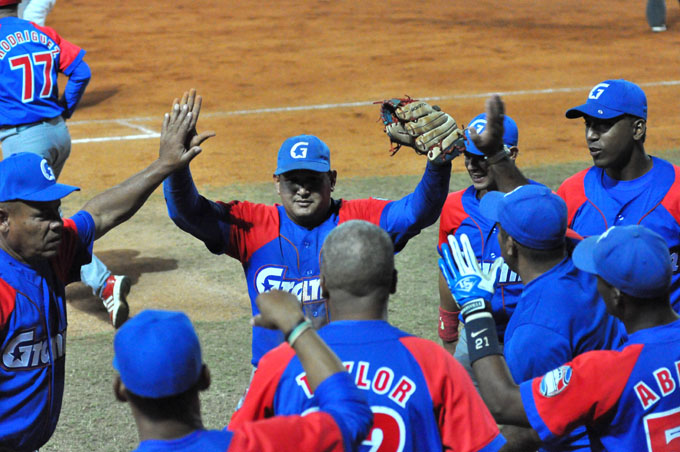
[{"x1": 250, "y1": 290, "x2": 305, "y2": 333}]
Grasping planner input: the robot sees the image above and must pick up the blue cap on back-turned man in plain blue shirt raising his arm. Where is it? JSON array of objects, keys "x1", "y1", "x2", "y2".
[{"x1": 479, "y1": 184, "x2": 567, "y2": 250}]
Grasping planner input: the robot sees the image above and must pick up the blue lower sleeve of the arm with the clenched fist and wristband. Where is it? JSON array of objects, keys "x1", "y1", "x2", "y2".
[{"x1": 314, "y1": 372, "x2": 373, "y2": 452}]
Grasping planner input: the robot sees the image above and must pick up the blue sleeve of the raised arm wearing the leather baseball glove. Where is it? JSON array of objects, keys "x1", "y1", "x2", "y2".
[{"x1": 380, "y1": 162, "x2": 451, "y2": 251}]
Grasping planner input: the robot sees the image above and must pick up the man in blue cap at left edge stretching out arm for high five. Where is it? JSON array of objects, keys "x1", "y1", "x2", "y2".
[{"x1": 0, "y1": 90, "x2": 210, "y2": 452}]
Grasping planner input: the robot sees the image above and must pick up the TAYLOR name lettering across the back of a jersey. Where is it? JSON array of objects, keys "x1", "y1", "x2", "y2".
[{"x1": 295, "y1": 361, "x2": 417, "y2": 408}]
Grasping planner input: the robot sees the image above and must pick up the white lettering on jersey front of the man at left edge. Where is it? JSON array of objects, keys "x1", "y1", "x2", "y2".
[{"x1": 2, "y1": 330, "x2": 66, "y2": 369}]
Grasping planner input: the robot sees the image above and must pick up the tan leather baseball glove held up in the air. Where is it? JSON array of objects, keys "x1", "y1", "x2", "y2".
[{"x1": 376, "y1": 96, "x2": 465, "y2": 165}]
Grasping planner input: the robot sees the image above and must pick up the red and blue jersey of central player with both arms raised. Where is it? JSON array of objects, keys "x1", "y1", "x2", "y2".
[{"x1": 163, "y1": 164, "x2": 450, "y2": 366}]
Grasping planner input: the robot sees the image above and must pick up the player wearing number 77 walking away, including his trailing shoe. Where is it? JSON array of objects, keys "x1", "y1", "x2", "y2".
[{"x1": 0, "y1": 0, "x2": 130, "y2": 328}]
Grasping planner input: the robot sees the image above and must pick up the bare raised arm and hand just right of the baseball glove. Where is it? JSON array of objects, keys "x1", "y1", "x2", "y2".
[{"x1": 468, "y1": 94, "x2": 529, "y2": 193}]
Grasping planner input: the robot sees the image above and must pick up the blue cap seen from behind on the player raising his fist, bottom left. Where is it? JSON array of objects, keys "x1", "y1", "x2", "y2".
[{"x1": 113, "y1": 310, "x2": 203, "y2": 399}]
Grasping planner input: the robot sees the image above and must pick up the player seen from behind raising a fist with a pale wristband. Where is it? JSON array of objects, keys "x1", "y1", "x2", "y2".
[{"x1": 113, "y1": 302, "x2": 372, "y2": 452}]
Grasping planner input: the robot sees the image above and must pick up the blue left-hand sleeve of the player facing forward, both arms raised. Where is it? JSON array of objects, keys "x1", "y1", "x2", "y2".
[{"x1": 163, "y1": 167, "x2": 229, "y2": 254}]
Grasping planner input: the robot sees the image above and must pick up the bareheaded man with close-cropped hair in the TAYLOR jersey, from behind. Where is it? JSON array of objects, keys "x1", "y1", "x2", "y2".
[{"x1": 229, "y1": 220, "x2": 505, "y2": 452}]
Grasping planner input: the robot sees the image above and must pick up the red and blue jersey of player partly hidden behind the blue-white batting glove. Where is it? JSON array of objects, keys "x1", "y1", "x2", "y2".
[{"x1": 439, "y1": 185, "x2": 523, "y2": 342}]
